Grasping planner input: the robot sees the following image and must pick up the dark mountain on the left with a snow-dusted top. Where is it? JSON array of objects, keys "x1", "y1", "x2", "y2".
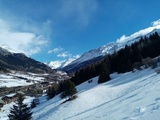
[{"x1": 0, "y1": 46, "x2": 53, "y2": 73}]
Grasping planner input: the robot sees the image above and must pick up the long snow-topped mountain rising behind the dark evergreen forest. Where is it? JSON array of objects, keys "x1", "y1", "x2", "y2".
[{"x1": 61, "y1": 25, "x2": 160, "y2": 73}]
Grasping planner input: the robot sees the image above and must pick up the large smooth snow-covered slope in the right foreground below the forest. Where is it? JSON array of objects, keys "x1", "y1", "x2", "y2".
[{"x1": 30, "y1": 69, "x2": 160, "y2": 120}]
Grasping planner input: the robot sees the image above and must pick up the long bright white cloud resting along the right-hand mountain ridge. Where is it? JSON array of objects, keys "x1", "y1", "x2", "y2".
[{"x1": 117, "y1": 19, "x2": 160, "y2": 43}]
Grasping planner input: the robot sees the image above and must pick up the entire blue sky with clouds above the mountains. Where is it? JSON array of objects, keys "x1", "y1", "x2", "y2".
[{"x1": 0, "y1": 0, "x2": 160, "y2": 62}]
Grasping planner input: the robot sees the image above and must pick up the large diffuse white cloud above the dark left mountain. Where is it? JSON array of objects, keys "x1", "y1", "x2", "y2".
[{"x1": 0, "y1": 19, "x2": 48, "y2": 55}]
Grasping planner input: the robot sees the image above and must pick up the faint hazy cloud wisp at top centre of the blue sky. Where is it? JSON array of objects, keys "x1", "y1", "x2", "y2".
[{"x1": 57, "y1": 0, "x2": 98, "y2": 27}]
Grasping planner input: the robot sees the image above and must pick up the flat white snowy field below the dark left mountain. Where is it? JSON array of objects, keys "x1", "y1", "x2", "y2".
[{"x1": 0, "y1": 72, "x2": 44, "y2": 87}]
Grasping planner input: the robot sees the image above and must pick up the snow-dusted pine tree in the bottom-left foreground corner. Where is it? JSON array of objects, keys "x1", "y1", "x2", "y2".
[{"x1": 8, "y1": 95, "x2": 32, "y2": 120}]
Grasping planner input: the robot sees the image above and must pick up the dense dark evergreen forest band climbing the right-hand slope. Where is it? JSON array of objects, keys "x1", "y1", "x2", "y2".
[{"x1": 71, "y1": 32, "x2": 160, "y2": 85}]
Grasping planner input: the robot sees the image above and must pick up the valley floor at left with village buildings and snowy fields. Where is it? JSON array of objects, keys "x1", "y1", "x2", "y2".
[{"x1": 0, "y1": 71, "x2": 69, "y2": 111}]
